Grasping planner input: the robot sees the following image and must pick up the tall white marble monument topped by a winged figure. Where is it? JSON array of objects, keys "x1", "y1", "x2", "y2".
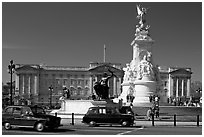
[{"x1": 119, "y1": 5, "x2": 161, "y2": 106}]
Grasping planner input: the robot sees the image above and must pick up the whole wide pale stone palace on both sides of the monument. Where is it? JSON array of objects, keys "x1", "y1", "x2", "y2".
[{"x1": 13, "y1": 62, "x2": 192, "y2": 106}]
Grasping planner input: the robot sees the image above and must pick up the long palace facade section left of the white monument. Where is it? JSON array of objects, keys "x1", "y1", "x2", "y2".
[{"x1": 14, "y1": 62, "x2": 123, "y2": 105}]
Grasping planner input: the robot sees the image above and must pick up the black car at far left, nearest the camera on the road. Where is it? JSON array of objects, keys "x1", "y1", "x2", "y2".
[{"x1": 2, "y1": 106, "x2": 61, "y2": 131}]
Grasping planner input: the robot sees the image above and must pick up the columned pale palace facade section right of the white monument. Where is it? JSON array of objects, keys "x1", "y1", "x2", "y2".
[{"x1": 159, "y1": 67, "x2": 192, "y2": 102}]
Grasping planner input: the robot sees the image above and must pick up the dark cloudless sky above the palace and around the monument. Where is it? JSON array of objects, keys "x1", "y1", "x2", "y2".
[{"x1": 2, "y1": 2, "x2": 202, "y2": 83}]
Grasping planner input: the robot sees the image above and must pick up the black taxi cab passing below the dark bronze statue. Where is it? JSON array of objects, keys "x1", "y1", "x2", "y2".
[{"x1": 82, "y1": 107, "x2": 135, "y2": 126}]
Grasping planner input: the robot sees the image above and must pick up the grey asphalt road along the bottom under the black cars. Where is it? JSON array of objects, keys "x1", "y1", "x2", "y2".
[{"x1": 2, "y1": 125, "x2": 202, "y2": 135}]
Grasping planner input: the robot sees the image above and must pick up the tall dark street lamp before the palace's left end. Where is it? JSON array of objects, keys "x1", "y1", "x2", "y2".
[{"x1": 8, "y1": 60, "x2": 15, "y2": 105}]
